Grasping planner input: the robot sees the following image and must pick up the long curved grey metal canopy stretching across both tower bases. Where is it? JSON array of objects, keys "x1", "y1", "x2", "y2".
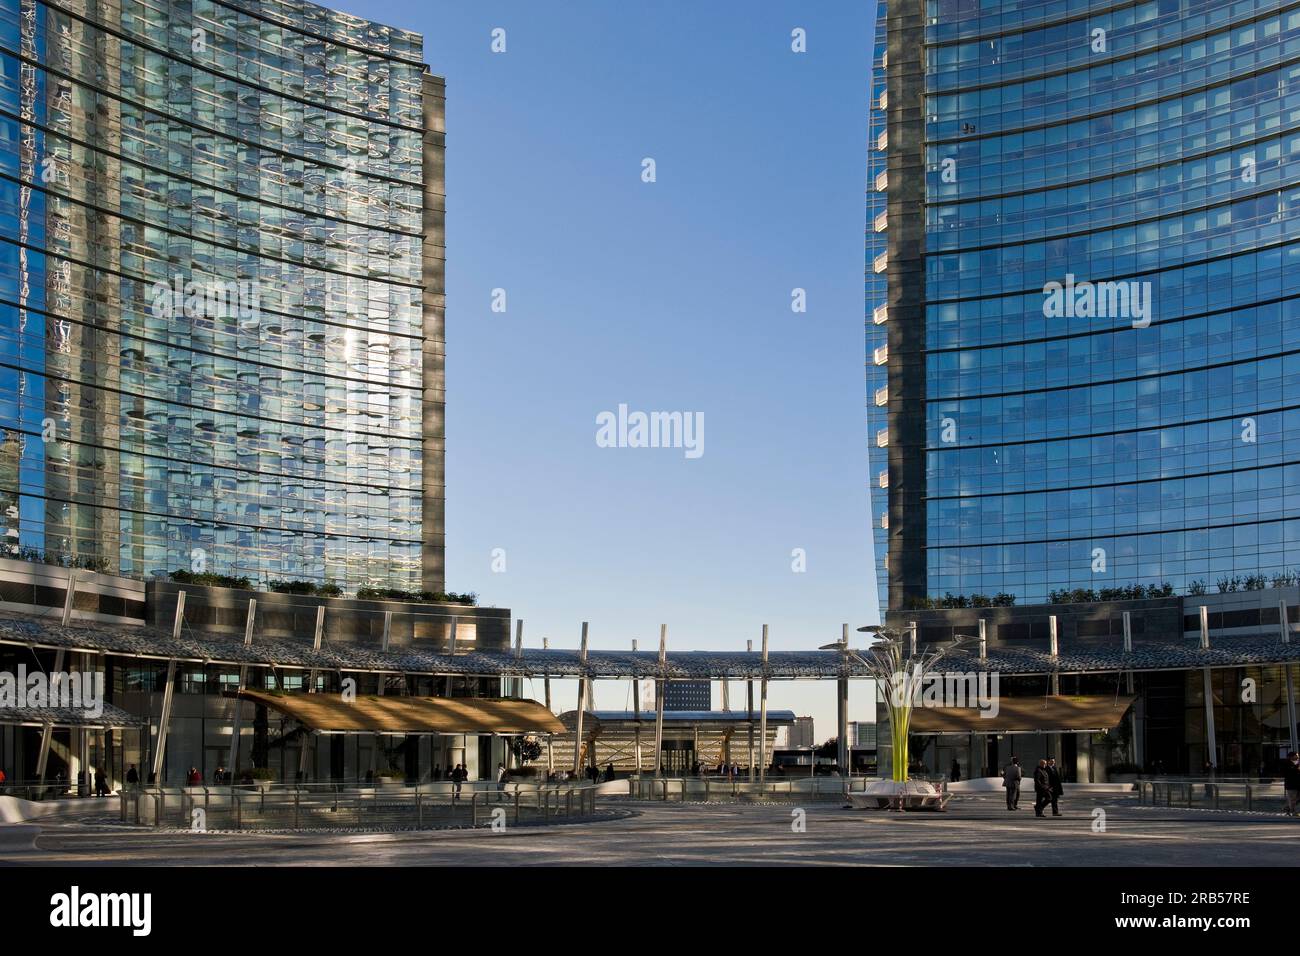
[{"x1": 0, "y1": 614, "x2": 1300, "y2": 680}]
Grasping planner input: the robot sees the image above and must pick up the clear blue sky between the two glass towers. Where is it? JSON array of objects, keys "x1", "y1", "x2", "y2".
[{"x1": 326, "y1": 0, "x2": 879, "y2": 739}]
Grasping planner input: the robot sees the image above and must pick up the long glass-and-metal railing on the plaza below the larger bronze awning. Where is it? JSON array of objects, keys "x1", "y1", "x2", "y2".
[{"x1": 120, "y1": 783, "x2": 595, "y2": 830}]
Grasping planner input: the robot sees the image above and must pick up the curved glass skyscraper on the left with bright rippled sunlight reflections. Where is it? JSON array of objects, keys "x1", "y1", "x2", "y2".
[{"x1": 0, "y1": 0, "x2": 445, "y2": 591}]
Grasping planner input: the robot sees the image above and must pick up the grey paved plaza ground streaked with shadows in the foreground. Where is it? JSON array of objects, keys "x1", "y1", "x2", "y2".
[{"x1": 0, "y1": 796, "x2": 1300, "y2": 866}]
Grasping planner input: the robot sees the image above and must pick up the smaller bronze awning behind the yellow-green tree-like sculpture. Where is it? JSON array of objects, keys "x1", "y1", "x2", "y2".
[{"x1": 907, "y1": 697, "x2": 1136, "y2": 734}]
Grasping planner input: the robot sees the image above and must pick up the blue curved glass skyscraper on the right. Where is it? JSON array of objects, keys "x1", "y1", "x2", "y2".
[{"x1": 867, "y1": 0, "x2": 1300, "y2": 610}]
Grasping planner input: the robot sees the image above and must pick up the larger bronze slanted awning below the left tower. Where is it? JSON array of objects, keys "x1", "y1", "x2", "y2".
[{"x1": 239, "y1": 691, "x2": 564, "y2": 734}]
